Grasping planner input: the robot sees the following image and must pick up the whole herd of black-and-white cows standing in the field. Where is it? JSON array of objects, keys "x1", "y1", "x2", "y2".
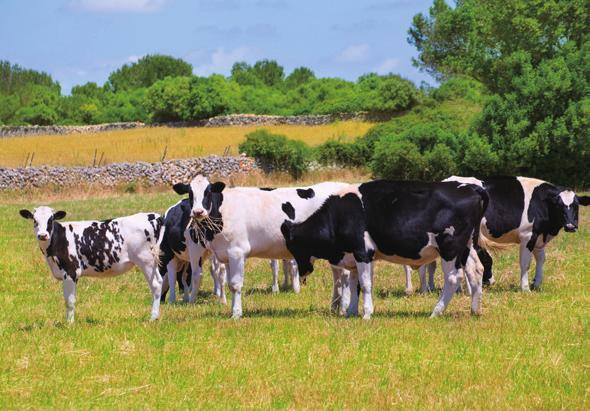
[{"x1": 20, "y1": 176, "x2": 590, "y2": 321}]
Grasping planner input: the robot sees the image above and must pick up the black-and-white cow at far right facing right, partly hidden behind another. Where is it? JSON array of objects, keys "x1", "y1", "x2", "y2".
[{"x1": 445, "y1": 176, "x2": 590, "y2": 291}]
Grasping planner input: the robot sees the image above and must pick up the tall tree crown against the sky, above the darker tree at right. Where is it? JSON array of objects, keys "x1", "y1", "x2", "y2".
[{"x1": 408, "y1": 0, "x2": 590, "y2": 92}]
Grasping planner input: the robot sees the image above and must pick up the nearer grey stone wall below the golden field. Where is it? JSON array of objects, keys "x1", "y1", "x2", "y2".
[{"x1": 0, "y1": 156, "x2": 258, "y2": 190}]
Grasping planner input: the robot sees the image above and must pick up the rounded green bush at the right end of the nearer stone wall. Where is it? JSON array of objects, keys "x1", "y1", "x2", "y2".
[{"x1": 239, "y1": 129, "x2": 311, "y2": 179}]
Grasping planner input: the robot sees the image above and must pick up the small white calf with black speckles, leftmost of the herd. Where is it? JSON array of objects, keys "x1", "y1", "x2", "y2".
[{"x1": 20, "y1": 206, "x2": 162, "y2": 322}]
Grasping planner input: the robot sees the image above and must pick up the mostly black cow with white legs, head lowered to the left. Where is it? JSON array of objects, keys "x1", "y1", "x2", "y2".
[{"x1": 281, "y1": 180, "x2": 487, "y2": 319}]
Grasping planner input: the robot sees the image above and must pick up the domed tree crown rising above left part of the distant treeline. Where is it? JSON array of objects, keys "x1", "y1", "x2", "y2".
[{"x1": 107, "y1": 54, "x2": 193, "y2": 92}]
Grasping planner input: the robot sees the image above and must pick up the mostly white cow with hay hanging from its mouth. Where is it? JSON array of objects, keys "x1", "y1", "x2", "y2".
[{"x1": 173, "y1": 176, "x2": 347, "y2": 319}]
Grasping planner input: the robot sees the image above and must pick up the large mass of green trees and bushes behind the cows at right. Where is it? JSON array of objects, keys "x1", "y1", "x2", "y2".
[{"x1": 242, "y1": 0, "x2": 590, "y2": 188}]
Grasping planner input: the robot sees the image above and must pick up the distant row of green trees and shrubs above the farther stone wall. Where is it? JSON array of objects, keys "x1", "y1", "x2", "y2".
[{"x1": 0, "y1": 55, "x2": 421, "y2": 125}]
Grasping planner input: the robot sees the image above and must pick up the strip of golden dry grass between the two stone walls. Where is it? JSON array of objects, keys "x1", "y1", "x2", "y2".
[{"x1": 0, "y1": 121, "x2": 373, "y2": 167}]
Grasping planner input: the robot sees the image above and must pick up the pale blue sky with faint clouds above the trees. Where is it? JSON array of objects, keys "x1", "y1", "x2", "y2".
[{"x1": 0, "y1": 0, "x2": 434, "y2": 93}]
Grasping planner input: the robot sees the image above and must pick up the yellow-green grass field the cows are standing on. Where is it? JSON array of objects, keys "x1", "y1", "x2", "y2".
[{"x1": 0, "y1": 193, "x2": 590, "y2": 410}]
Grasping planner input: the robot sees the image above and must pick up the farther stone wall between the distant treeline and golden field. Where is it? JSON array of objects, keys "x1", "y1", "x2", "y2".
[{"x1": 0, "y1": 113, "x2": 391, "y2": 138}]
